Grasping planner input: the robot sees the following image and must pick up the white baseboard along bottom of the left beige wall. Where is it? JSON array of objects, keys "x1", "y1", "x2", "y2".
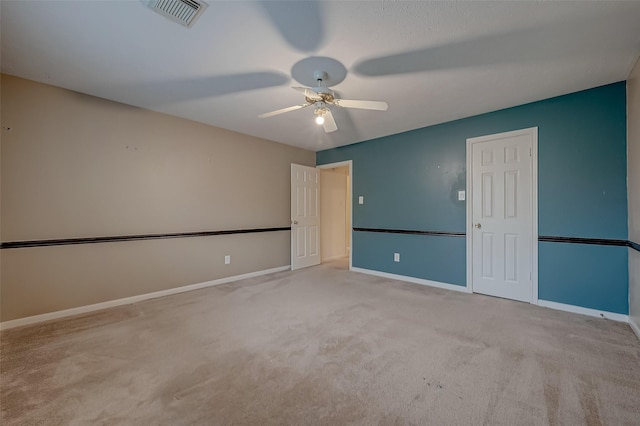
[{"x1": 0, "y1": 265, "x2": 291, "y2": 330}]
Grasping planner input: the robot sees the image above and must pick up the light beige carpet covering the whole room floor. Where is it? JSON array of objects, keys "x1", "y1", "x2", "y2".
[{"x1": 0, "y1": 262, "x2": 640, "y2": 425}]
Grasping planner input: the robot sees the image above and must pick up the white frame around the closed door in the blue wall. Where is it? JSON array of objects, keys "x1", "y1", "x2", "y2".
[{"x1": 466, "y1": 127, "x2": 538, "y2": 305}]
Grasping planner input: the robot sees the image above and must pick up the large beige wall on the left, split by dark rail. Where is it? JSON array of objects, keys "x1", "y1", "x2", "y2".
[{"x1": 0, "y1": 75, "x2": 315, "y2": 321}]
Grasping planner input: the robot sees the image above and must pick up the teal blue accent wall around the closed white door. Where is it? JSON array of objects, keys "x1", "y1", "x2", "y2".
[{"x1": 316, "y1": 82, "x2": 628, "y2": 314}]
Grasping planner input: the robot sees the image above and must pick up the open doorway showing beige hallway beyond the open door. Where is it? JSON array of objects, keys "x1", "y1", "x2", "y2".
[{"x1": 318, "y1": 161, "x2": 352, "y2": 269}]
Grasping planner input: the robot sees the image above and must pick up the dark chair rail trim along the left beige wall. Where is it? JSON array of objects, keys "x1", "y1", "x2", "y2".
[{"x1": 0, "y1": 226, "x2": 291, "y2": 250}]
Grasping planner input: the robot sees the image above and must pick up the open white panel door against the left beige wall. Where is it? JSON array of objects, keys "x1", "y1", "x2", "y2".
[{"x1": 291, "y1": 164, "x2": 320, "y2": 270}]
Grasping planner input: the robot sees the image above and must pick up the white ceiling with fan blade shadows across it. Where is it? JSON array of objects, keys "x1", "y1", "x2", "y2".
[{"x1": 0, "y1": 0, "x2": 640, "y2": 151}]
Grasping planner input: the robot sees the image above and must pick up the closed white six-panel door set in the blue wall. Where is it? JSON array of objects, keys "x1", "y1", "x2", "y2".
[{"x1": 467, "y1": 128, "x2": 537, "y2": 303}]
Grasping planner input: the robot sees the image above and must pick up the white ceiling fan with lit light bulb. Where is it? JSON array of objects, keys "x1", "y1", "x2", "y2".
[{"x1": 258, "y1": 71, "x2": 389, "y2": 133}]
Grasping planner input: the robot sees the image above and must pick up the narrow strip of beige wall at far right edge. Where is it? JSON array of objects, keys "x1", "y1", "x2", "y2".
[{"x1": 627, "y1": 55, "x2": 640, "y2": 337}]
